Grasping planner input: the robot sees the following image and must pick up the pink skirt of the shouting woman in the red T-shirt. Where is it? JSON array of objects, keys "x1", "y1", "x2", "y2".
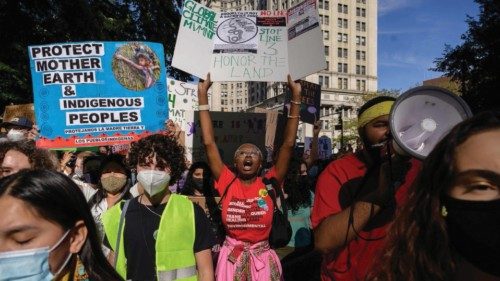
[{"x1": 215, "y1": 236, "x2": 283, "y2": 281}]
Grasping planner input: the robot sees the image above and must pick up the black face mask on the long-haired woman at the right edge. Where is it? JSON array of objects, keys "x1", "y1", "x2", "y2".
[{"x1": 442, "y1": 197, "x2": 500, "y2": 276}]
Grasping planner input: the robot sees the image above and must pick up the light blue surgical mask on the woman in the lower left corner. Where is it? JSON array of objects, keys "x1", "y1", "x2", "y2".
[{"x1": 0, "y1": 230, "x2": 72, "y2": 281}]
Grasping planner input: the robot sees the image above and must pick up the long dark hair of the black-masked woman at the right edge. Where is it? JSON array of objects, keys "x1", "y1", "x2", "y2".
[{"x1": 367, "y1": 112, "x2": 500, "y2": 281}]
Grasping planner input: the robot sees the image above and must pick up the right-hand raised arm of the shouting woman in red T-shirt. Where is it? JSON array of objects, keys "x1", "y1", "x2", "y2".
[{"x1": 275, "y1": 75, "x2": 302, "y2": 182}]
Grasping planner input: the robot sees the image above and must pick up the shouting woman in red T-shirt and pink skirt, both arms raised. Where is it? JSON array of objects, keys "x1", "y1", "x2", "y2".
[{"x1": 198, "y1": 74, "x2": 301, "y2": 281}]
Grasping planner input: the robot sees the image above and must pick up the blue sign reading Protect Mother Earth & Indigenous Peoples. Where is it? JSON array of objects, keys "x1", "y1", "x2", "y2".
[{"x1": 28, "y1": 42, "x2": 168, "y2": 148}]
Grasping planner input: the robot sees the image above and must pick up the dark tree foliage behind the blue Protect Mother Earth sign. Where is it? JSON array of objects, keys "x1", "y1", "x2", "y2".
[{"x1": 0, "y1": 0, "x2": 190, "y2": 113}]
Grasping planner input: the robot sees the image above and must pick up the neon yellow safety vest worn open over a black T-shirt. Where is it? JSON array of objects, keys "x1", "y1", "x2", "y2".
[{"x1": 102, "y1": 194, "x2": 197, "y2": 281}]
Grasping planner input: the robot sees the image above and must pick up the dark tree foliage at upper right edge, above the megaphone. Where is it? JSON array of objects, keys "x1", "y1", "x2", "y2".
[{"x1": 433, "y1": 0, "x2": 500, "y2": 112}]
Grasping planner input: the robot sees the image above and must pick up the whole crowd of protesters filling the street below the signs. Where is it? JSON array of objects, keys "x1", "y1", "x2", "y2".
[{"x1": 0, "y1": 78, "x2": 500, "y2": 281}]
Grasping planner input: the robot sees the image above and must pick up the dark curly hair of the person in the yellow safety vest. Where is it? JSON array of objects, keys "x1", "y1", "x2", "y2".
[{"x1": 127, "y1": 134, "x2": 187, "y2": 185}]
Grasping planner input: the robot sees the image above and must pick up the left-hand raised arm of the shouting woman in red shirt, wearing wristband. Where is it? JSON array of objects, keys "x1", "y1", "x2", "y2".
[{"x1": 198, "y1": 73, "x2": 224, "y2": 179}]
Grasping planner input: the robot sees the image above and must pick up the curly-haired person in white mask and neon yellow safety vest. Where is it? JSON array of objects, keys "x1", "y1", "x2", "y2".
[{"x1": 102, "y1": 134, "x2": 215, "y2": 281}]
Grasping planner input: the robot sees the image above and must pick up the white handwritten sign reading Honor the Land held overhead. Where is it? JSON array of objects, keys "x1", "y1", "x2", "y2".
[{"x1": 172, "y1": 0, "x2": 326, "y2": 81}]
